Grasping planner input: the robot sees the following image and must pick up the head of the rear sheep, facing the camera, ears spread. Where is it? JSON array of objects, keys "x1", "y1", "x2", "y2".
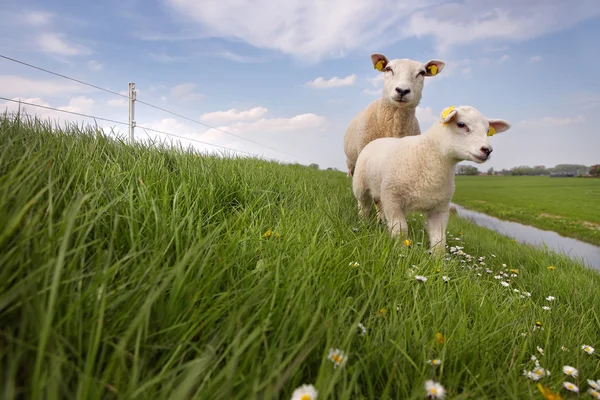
[{"x1": 371, "y1": 54, "x2": 445, "y2": 108}]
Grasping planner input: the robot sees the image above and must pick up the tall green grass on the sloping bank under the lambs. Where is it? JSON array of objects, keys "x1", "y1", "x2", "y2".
[{"x1": 0, "y1": 113, "x2": 600, "y2": 400}]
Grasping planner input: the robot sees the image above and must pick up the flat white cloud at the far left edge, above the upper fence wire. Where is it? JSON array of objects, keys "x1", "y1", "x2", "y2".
[{"x1": 0, "y1": 75, "x2": 90, "y2": 98}]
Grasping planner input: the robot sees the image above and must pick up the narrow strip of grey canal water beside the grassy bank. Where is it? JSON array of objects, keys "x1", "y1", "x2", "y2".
[{"x1": 451, "y1": 203, "x2": 600, "y2": 270}]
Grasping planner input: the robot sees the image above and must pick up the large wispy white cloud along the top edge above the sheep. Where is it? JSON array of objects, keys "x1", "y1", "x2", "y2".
[{"x1": 164, "y1": 0, "x2": 600, "y2": 62}]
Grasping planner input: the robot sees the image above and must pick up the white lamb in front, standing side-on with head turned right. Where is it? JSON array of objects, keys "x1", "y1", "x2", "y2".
[{"x1": 352, "y1": 106, "x2": 510, "y2": 254}]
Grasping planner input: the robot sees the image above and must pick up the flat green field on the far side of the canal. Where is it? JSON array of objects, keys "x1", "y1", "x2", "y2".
[{"x1": 453, "y1": 176, "x2": 600, "y2": 245}]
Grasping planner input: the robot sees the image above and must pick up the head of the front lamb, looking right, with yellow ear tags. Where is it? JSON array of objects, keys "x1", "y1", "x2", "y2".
[{"x1": 441, "y1": 106, "x2": 510, "y2": 164}]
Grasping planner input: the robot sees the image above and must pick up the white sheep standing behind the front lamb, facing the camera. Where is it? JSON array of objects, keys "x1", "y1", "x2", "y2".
[{"x1": 344, "y1": 54, "x2": 445, "y2": 176}]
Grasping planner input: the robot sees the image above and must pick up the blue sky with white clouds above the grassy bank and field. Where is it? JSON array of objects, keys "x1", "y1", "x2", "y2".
[{"x1": 0, "y1": 0, "x2": 600, "y2": 171}]
